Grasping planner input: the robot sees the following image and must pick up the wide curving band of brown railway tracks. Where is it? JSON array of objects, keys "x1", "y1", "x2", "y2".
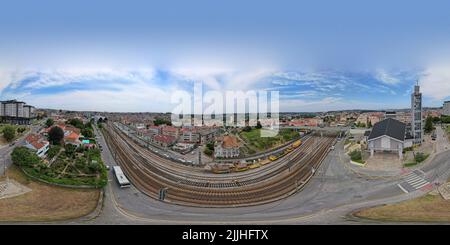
[{"x1": 104, "y1": 123, "x2": 334, "y2": 207}]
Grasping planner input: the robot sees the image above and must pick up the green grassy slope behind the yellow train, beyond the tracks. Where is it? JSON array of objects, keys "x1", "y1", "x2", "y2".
[{"x1": 240, "y1": 129, "x2": 299, "y2": 151}]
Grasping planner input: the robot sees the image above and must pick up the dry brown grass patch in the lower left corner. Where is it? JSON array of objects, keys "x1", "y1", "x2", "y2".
[{"x1": 0, "y1": 165, "x2": 100, "y2": 221}]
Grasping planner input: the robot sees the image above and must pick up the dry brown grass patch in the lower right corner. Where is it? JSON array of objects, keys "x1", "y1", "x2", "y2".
[{"x1": 354, "y1": 195, "x2": 450, "y2": 222}]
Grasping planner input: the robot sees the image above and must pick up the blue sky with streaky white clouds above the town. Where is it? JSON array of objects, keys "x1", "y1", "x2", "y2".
[{"x1": 0, "y1": 0, "x2": 450, "y2": 112}]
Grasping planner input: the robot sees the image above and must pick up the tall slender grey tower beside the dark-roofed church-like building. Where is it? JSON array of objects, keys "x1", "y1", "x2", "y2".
[{"x1": 411, "y1": 82, "x2": 423, "y2": 144}]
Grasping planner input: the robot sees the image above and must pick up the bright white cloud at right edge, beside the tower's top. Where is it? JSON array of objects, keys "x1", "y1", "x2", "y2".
[{"x1": 419, "y1": 64, "x2": 450, "y2": 100}]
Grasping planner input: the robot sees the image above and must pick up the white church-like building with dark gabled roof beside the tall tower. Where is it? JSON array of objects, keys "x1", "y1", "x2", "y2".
[{"x1": 367, "y1": 118, "x2": 412, "y2": 159}]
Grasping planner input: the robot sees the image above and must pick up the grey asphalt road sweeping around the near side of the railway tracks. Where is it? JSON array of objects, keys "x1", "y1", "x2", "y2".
[{"x1": 79, "y1": 124, "x2": 450, "y2": 224}]
